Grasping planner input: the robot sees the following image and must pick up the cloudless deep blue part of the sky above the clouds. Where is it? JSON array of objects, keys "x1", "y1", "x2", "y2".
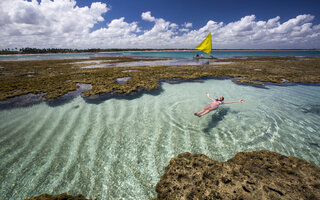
[{"x1": 77, "y1": 0, "x2": 320, "y2": 29}]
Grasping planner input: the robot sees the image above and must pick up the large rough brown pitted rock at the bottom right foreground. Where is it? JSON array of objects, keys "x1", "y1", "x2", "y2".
[{"x1": 156, "y1": 150, "x2": 320, "y2": 199}]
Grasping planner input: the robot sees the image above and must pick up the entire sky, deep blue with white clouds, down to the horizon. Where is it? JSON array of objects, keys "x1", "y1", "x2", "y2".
[{"x1": 0, "y1": 0, "x2": 320, "y2": 49}]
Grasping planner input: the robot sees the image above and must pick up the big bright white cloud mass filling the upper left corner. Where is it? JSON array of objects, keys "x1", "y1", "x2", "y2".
[{"x1": 0, "y1": 0, "x2": 109, "y2": 47}]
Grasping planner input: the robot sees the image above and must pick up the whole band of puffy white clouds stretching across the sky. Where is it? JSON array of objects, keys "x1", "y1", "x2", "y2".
[{"x1": 0, "y1": 0, "x2": 320, "y2": 48}]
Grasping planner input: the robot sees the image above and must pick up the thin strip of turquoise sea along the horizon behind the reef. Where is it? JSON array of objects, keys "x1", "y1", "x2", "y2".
[{"x1": 0, "y1": 51, "x2": 320, "y2": 60}]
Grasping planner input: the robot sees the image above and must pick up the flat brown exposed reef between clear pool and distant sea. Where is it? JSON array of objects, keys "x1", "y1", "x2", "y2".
[{"x1": 0, "y1": 57, "x2": 320, "y2": 101}]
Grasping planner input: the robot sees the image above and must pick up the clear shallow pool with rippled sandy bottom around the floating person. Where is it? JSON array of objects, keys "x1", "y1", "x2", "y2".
[{"x1": 0, "y1": 79, "x2": 320, "y2": 200}]
